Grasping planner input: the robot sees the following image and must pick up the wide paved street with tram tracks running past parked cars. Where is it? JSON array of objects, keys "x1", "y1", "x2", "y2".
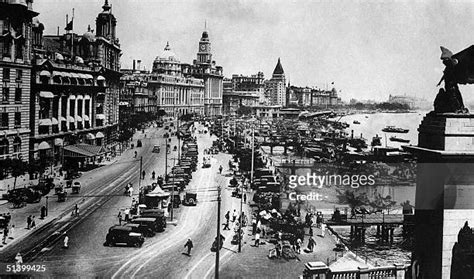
[{"x1": 3, "y1": 124, "x2": 252, "y2": 278}]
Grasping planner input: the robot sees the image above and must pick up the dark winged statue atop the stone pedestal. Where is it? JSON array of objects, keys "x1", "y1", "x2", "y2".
[{"x1": 434, "y1": 46, "x2": 474, "y2": 113}]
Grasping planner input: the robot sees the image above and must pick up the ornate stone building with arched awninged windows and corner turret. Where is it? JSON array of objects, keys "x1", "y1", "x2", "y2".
[{"x1": 29, "y1": 0, "x2": 120, "y2": 163}]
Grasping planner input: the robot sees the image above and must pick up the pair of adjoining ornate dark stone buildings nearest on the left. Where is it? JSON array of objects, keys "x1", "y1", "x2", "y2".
[{"x1": 0, "y1": 0, "x2": 121, "y2": 168}]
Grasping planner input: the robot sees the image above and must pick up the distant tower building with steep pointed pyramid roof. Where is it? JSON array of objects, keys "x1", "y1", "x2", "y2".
[{"x1": 265, "y1": 58, "x2": 287, "y2": 106}]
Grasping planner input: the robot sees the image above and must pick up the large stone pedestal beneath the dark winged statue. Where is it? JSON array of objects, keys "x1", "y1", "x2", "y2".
[{"x1": 406, "y1": 113, "x2": 474, "y2": 279}]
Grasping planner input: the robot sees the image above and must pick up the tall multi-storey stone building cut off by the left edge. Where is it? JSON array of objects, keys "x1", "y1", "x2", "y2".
[{"x1": 0, "y1": 0, "x2": 38, "y2": 161}]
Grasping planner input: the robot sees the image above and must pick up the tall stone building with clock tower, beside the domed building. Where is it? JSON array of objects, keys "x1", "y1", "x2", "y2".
[{"x1": 190, "y1": 31, "x2": 224, "y2": 116}]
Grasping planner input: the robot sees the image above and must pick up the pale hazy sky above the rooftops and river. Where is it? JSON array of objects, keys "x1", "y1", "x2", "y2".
[{"x1": 33, "y1": 0, "x2": 474, "y2": 102}]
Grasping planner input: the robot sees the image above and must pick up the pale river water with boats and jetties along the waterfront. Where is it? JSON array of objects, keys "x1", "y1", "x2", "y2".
[{"x1": 265, "y1": 112, "x2": 427, "y2": 265}]
